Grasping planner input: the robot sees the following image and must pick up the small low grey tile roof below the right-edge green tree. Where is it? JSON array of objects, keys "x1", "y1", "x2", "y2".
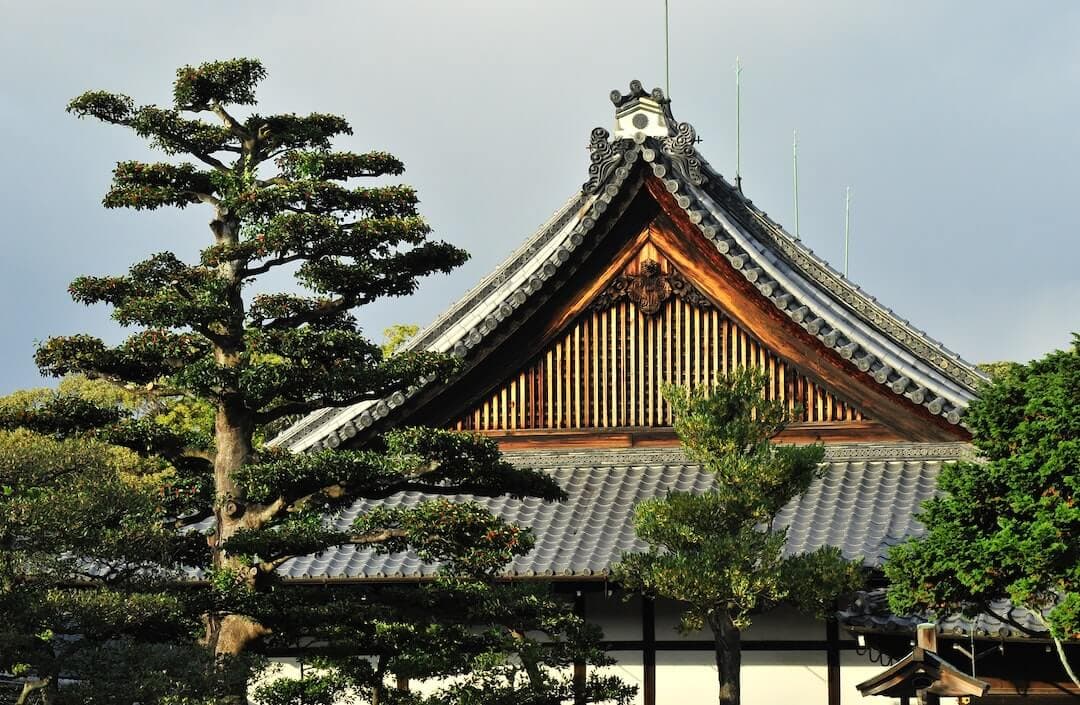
[{"x1": 838, "y1": 587, "x2": 1049, "y2": 640}]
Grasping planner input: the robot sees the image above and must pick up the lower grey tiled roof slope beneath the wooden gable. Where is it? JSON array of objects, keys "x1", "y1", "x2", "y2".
[{"x1": 270, "y1": 444, "x2": 971, "y2": 581}]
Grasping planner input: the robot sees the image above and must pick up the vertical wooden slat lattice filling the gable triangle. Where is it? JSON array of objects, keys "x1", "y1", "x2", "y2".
[{"x1": 455, "y1": 291, "x2": 864, "y2": 431}]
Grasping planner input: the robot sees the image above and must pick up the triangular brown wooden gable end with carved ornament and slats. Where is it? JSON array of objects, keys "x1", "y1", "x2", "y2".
[{"x1": 445, "y1": 178, "x2": 967, "y2": 447}]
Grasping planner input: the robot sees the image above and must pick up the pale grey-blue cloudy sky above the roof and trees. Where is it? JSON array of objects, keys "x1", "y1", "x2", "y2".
[{"x1": 0, "y1": 0, "x2": 1080, "y2": 393}]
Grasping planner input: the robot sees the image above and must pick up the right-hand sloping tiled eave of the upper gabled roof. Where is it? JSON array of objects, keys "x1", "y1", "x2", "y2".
[{"x1": 613, "y1": 129, "x2": 986, "y2": 424}]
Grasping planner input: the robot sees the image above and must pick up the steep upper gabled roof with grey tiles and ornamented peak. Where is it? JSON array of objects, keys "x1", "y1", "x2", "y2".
[{"x1": 275, "y1": 81, "x2": 986, "y2": 451}]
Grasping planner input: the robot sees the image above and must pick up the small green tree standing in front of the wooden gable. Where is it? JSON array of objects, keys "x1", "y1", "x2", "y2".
[{"x1": 615, "y1": 369, "x2": 862, "y2": 705}]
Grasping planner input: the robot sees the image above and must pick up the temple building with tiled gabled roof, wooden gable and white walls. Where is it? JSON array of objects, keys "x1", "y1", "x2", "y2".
[{"x1": 276, "y1": 81, "x2": 1075, "y2": 705}]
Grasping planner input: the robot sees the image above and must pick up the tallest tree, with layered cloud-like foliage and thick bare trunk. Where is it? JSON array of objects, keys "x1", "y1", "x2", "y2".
[{"x1": 12, "y1": 59, "x2": 626, "y2": 703}]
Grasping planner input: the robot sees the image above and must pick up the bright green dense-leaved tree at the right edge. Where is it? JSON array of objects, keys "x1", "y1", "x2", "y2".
[{"x1": 885, "y1": 336, "x2": 1080, "y2": 686}]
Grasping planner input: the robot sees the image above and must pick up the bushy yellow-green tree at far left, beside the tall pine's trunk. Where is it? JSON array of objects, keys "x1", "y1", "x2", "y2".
[{"x1": 0, "y1": 380, "x2": 233, "y2": 704}]
